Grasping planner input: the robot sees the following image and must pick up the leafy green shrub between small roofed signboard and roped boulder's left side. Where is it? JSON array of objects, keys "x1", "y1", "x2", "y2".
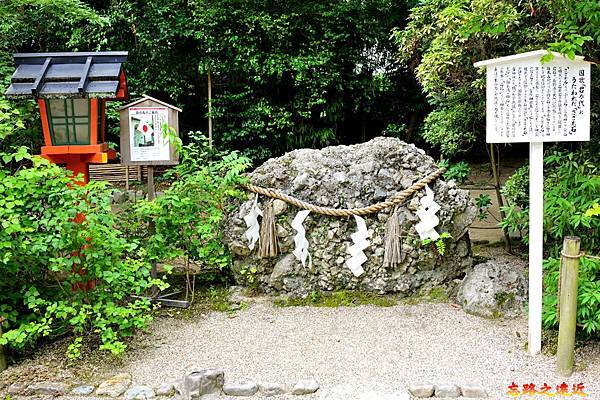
[{"x1": 130, "y1": 132, "x2": 250, "y2": 268}]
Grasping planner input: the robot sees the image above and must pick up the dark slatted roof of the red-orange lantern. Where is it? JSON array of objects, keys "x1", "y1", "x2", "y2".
[{"x1": 6, "y1": 51, "x2": 127, "y2": 98}]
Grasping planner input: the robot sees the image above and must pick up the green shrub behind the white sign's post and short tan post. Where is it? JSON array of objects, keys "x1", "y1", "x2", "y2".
[{"x1": 502, "y1": 152, "x2": 600, "y2": 334}]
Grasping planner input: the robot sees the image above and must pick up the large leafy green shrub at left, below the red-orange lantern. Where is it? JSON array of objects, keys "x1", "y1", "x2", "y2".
[{"x1": 0, "y1": 152, "x2": 164, "y2": 357}]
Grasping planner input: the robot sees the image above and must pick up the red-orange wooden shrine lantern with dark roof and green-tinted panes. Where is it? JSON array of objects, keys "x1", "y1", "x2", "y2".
[{"x1": 6, "y1": 51, "x2": 129, "y2": 185}]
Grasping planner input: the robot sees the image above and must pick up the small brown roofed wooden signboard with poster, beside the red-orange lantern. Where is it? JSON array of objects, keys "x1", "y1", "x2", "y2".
[{"x1": 120, "y1": 96, "x2": 181, "y2": 165}]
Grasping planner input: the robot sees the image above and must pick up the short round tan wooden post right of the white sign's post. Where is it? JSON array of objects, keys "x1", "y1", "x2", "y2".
[{"x1": 556, "y1": 236, "x2": 581, "y2": 376}]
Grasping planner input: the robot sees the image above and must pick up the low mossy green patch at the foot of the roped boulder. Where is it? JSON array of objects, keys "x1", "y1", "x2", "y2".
[{"x1": 274, "y1": 290, "x2": 397, "y2": 307}]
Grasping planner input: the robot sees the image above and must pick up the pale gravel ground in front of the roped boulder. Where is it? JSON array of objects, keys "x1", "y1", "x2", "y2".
[{"x1": 119, "y1": 299, "x2": 600, "y2": 400}]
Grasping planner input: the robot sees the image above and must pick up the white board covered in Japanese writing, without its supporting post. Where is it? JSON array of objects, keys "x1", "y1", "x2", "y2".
[{"x1": 477, "y1": 52, "x2": 591, "y2": 143}]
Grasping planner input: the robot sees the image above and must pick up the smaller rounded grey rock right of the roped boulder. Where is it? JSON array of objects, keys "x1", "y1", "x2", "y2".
[{"x1": 458, "y1": 260, "x2": 527, "y2": 318}]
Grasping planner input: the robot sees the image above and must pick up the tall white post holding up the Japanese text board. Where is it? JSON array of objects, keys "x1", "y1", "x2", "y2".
[{"x1": 528, "y1": 142, "x2": 544, "y2": 355}]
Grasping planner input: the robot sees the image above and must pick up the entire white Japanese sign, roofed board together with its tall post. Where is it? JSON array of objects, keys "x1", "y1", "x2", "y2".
[{"x1": 474, "y1": 50, "x2": 591, "y2": 355}]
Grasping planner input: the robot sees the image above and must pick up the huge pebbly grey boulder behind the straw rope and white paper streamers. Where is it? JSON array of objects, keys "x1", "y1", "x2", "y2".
[{"x1": 223, "y1": 137, "x2": 477, "y2": 296}]
